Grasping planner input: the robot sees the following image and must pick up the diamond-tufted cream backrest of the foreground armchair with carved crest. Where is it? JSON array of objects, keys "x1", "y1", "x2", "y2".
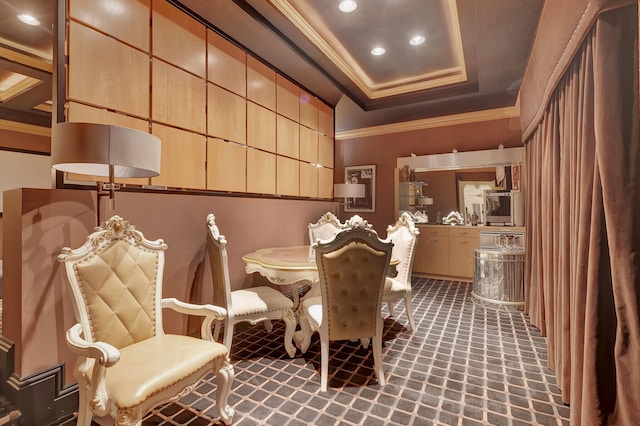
[{"x1": 58, "y1": 216, "x2": 167, "y2": 349}]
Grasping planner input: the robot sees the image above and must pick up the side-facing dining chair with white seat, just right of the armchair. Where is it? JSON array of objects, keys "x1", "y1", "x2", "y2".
[{"x1": 207, "y1": 214, "x2": 297, "y2": 358}]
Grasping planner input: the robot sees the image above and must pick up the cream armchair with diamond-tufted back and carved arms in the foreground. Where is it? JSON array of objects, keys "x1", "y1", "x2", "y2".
[{"x1": 58, "y1": 216, "x2": 234, "y2": 426}]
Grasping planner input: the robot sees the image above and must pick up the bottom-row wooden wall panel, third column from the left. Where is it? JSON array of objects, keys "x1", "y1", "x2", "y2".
[{"x1": 207, "y1": 138, "x2": 247, "y2": 192}]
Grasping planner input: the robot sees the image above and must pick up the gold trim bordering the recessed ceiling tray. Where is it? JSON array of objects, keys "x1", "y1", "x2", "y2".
[{"x1": 270, "y1": 0, "x2": 467, "y2": 100}]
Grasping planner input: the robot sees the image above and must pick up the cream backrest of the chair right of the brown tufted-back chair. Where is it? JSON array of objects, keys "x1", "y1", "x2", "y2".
[{"x1": 387, "y1": 212, "x2": 420, "y2": 284}]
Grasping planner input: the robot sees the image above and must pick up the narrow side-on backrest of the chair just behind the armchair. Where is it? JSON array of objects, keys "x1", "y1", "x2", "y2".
[{"x1": 207, "y1": 213, "x2": 233, "y2": 319}]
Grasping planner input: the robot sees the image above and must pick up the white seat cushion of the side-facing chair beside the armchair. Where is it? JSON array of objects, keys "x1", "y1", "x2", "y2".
[{"x1": 231, "y1": 286, "x2": 293, "y2": 315}]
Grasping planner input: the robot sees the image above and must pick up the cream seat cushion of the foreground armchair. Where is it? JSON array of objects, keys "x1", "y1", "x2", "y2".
[{"x1": 106, "y1": 334, "x2": 227, "y2": 408}]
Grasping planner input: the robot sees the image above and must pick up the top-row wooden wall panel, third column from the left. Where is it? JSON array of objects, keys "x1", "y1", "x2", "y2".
[{"x1": 207, "y1": 30, "x2": 247, "y2": 97}]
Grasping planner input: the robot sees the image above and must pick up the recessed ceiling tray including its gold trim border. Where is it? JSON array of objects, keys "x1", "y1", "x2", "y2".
[{"x1": 270, "y1": 0, "x2": 466, "y2": 100}]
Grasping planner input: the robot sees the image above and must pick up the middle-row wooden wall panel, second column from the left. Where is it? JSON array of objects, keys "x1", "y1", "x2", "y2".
[{"x1": 151, "y1": 59, "x2": 207, "y2": 133}]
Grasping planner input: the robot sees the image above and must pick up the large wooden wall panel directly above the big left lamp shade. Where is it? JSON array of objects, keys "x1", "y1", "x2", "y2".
[{"x1": 67, "y1": 21, "x2": 149, "y2": 118}]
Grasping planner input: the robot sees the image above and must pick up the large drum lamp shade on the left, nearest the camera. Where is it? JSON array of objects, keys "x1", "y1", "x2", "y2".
[{"x1": 51, "y1": 123, "x2": 161, "y2": 178}]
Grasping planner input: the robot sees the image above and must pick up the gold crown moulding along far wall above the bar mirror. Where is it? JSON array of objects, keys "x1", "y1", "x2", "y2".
[{"x1": 335, "y1": 103, "x2": 520, "y2": 140}]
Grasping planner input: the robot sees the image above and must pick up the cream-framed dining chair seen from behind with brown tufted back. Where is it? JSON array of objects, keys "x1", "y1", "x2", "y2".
[{"x1": 300, "y1": 222, "x2": 393, "y2": 392}]
